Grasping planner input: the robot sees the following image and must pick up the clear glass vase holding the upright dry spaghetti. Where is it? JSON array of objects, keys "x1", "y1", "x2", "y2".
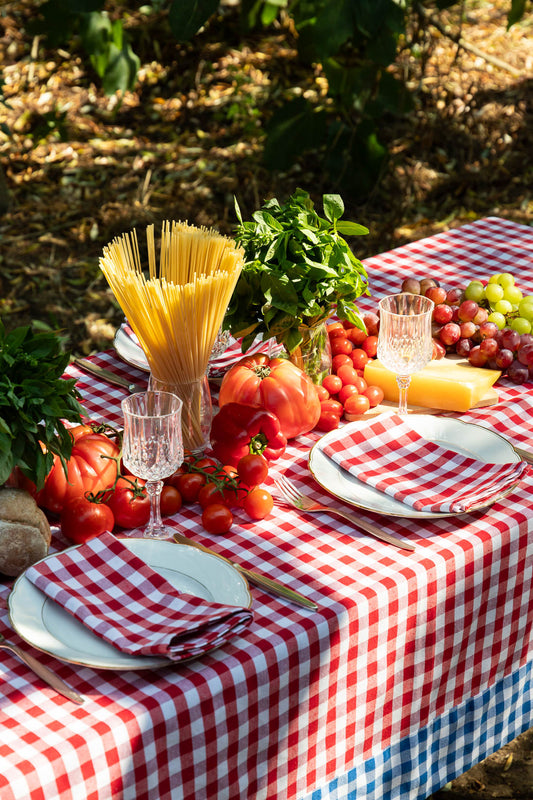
[{"x1": 148, "y1": 374, "x2": 213, "y2": 453}]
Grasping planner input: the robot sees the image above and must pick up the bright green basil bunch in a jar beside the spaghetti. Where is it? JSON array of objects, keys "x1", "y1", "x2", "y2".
[{"x1": 224, "y1": 189, "x2": 369, "y2": 353}]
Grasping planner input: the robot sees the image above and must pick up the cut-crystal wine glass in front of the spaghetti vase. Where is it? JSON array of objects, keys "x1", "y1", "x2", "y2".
[{"x1": 121, "y1": 391, "x2": 183, "y2": 539}]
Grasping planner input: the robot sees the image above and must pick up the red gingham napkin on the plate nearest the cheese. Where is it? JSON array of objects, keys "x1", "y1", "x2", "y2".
[{"x1": 324, "y1": 414, "x2": 531, "y2": 513}]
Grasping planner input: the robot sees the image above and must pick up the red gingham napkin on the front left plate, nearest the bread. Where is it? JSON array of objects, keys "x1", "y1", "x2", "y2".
[{"x1": 26, "y1": 532, "x2": 252, "y2": 661}]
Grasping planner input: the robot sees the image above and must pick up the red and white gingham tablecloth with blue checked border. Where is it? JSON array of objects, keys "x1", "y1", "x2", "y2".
[{"x1": 0, "y1": 218, "x2": 533, "y2": 800}]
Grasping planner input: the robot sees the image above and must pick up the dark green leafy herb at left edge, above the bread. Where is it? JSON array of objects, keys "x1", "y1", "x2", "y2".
[{"x1": 0, "y1": 320, "x2": 83, "y2": 489}]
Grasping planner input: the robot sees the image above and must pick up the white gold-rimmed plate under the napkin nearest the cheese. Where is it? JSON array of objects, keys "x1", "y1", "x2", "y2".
[{"x1": 309, "y1": 414, "x2": 520, "y2": 519}]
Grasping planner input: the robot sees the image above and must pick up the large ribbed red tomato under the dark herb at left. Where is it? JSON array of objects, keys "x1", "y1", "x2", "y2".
[{"x1": 32, "y1": 431, "x2": 120, "y2": 514}]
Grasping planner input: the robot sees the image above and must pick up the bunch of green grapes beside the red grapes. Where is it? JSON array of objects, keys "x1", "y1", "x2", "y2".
[{"x1": 464, "y1": 272, "x2": 533, "y2": 334}]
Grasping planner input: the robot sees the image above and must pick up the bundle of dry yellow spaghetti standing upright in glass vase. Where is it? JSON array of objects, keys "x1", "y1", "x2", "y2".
[{"x1": 100, "y1": 221, "x2": 243, "y2": 450}]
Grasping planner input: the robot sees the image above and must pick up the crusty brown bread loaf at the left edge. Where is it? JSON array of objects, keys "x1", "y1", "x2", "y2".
[{"x1": 0, "y1": 488, "x2": 51, "y2": 576}]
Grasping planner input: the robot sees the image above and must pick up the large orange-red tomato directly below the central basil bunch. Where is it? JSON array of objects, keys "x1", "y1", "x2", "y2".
[{"x1": 218, "y1": 354, "x2": 320, "y2": 439}]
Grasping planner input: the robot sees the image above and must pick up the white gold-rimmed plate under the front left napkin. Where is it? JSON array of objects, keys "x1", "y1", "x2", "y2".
[{"x1": 8, "y1": 539, "x2": 252, "y2": 670}]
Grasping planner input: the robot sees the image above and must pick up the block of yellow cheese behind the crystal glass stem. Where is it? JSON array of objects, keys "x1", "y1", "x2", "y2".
[{"x1": 364, "y1": 358, "x2": 501, "y2": 411}]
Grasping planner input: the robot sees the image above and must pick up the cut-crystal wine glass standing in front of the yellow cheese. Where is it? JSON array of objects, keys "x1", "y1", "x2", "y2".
[{"x1": 377, "y1": 293, "x2": 434, "y2": 414}]
